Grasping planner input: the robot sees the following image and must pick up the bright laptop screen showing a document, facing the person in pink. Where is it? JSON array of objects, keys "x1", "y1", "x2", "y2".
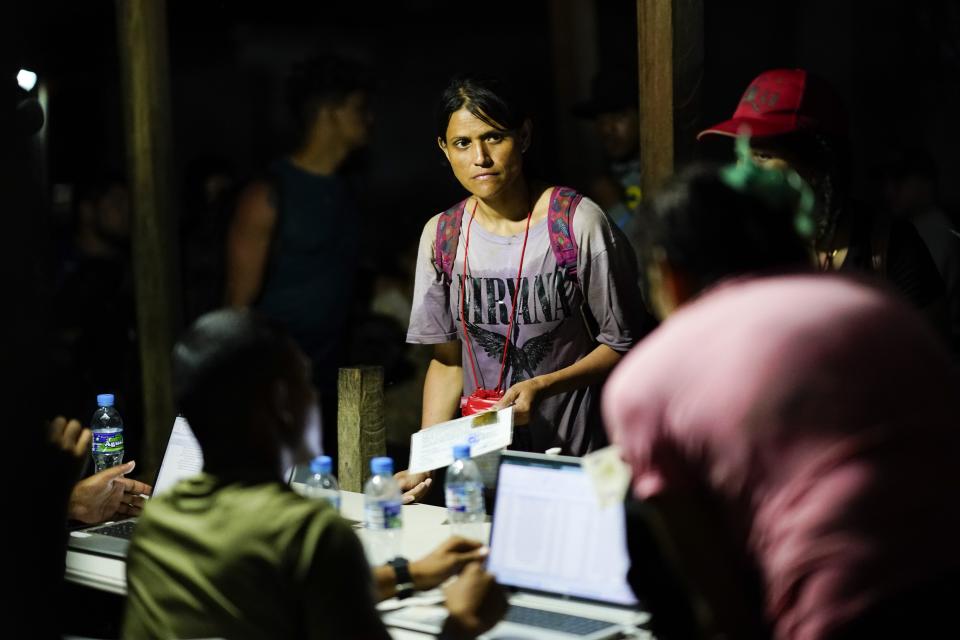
[{"x1": 487, "y1": 460, "x2": 637, "y2": 605}]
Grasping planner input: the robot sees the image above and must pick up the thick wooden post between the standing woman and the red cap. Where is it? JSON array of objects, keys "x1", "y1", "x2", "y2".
[{"x1": 637, "y1": 0, "x2": 703, "y2": 198}]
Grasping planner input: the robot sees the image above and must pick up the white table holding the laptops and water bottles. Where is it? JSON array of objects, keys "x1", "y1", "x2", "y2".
[{"x1": 65, "y1": 491, "x2": 490, "y2": 638}]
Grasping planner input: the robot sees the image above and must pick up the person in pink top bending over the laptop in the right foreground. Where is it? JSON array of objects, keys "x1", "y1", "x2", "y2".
[{"x1": 602, "y1": 162, "x2": 960, "y2": 640}]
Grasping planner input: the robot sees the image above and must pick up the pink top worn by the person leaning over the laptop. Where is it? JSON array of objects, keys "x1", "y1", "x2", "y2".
[{"x1": 603, "y1": 275, "x2": 960, "y2": 640}]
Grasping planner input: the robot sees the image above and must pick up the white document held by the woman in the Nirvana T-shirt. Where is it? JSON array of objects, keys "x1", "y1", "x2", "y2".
[{"x1": 409, "y1": 407, "x2": 513, "y2": 473}]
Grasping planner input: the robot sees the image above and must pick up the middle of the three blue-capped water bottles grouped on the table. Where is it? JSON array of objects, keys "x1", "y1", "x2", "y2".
[{"x1": 363, "y1": 457, "x2": 403, "y2": 565}]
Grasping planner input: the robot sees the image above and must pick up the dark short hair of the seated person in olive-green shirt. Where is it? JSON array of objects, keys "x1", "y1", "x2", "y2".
[{"x1": 173, "y1": 309, "x2": 292, "y2": 446}]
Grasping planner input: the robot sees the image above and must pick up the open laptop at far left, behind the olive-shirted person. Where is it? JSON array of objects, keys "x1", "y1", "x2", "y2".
[{"x1": 68, "y1": 416, "x2": 203, "y2": 558}]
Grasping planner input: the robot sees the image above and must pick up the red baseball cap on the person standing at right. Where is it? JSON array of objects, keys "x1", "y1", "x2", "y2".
[{"x1": 697, "y1": 69, "x2": 847, "y2": 140}]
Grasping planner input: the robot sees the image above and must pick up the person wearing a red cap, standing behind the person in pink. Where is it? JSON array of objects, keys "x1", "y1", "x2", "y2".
[{"x1": 697, "y1": 69, "x2": 945, "y2": 328}]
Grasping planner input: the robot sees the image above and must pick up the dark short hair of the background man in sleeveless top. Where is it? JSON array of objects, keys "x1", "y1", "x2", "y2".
[{"x1": 286, "y1": 54, "x2": 371, "y2": 130}]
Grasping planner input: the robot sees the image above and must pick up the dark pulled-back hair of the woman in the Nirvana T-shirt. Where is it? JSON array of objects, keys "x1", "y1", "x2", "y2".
[{"x1": 437, "y1": 73, "x2": 529, "y2": 140}]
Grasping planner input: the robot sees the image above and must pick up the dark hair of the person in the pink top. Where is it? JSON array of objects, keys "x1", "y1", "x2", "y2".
[{"x1": 642, "y1": 165, "x2": 810, "y2": 287}]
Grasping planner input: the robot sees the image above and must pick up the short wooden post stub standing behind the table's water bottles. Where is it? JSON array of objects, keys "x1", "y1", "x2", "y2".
[{"x1": 337, "y1": 367, "x2": 387, "y2": 491}]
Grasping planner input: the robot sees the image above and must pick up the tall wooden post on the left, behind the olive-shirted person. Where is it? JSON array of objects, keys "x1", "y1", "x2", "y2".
[{"x1": 116, "y1": 0, "x2": 179, "y2": 472}]
